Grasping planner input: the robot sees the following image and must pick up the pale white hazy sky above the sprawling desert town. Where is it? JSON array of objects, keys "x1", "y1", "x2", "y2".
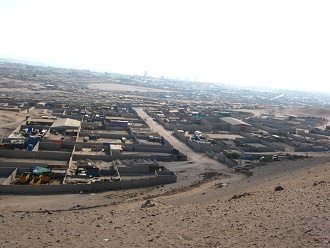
[{"x1": 0, "y1": 0, "x2": 330, "y2": 92}]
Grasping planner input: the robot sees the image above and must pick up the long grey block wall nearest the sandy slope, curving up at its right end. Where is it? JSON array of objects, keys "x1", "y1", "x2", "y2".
[{"x1": 0, "y1": 173, "x2": 177, "y2": 195}]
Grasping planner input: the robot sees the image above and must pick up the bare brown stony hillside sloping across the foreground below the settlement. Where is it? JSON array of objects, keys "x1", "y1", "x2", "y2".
[{"x1": 0, "y1": 159, "x2": 330, "y2": 247}]
